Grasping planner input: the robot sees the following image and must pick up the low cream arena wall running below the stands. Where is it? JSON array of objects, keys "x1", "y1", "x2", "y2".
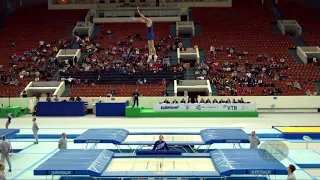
[{"x1": 0, "y1": 96, "x2": 320, "y2": 112}]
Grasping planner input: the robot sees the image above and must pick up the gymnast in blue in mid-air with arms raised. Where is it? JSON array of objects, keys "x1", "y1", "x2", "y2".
[{"x1": 133, "y1": 7, "x2": 158, "y2": 63}]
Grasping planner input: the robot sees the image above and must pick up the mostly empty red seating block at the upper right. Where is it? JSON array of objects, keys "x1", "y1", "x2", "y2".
[{"x1": 192, "y1": 0, "x2": 320, "y2": 95}]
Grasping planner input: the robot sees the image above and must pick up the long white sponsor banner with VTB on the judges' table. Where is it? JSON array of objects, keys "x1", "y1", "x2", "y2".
[{"x1": 153, "y1": 103, "x2": 257, "y2": 112}]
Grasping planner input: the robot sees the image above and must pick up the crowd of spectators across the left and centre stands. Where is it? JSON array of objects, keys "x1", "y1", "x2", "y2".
[{"x1": 0, "y1": 27, "x2": 183, "y2": 90}]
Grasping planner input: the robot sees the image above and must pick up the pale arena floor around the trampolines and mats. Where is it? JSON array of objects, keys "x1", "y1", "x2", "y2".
[{"x1": 1, "y1": 113, "x2": 320, "y2": 180}]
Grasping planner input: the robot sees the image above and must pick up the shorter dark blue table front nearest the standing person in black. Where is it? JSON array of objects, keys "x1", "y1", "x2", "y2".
[{"x1": 96, "y1": 101, "x2": 129, "y2": 116}]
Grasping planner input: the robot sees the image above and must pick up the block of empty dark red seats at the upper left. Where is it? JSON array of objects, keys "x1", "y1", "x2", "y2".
[{"x1": 0, "y1": 6, "x2": 87, "y2": 97}]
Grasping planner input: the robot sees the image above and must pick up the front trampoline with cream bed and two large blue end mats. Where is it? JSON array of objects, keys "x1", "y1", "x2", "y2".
[{"x1": 34, "y1": 149, "x2": 287, "y2": 179}]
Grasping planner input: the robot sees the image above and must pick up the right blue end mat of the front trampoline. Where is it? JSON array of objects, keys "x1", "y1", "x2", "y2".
[{"x1": 210, "y1": 149, "x2": 288, "y2": 176}]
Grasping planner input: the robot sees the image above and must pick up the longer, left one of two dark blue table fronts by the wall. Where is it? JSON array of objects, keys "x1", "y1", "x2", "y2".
[{"x1": 37, "y1": 102, "x2": 85, "y2": 116}]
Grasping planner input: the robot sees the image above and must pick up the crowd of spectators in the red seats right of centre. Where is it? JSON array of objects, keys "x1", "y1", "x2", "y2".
[{"x1": 191, "y1": 46, "x2": 317, "y2": 96}]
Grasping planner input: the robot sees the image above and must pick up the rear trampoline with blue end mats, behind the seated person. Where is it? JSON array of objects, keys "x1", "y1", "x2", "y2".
[{"x1": 74, "y1": 129, "x2": 249, "y2": 153}]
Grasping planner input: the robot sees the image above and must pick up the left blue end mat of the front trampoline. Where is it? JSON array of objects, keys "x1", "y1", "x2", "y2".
[{"x1": 34, "y1": 149, "x2": 114, "y2": 176}]
